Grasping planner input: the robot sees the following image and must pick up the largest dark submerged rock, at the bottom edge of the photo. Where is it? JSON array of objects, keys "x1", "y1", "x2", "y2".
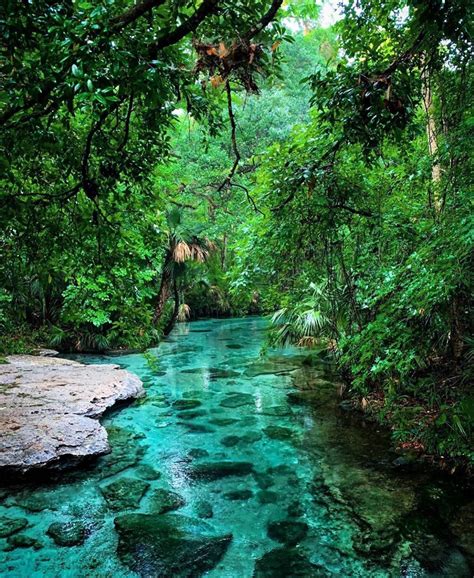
[{"x1": 115, "y1": 514, "x2": 232, "y2": 578}]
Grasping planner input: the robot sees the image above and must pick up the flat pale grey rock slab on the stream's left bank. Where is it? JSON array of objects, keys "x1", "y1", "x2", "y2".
[{"x1": 0, "y1": 355, "x2": 145, "y2": 473}]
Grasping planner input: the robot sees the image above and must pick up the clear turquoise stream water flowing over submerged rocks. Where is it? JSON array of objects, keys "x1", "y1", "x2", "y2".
[{"x1": 0, "y1": 318, "x2": 474, "y2": 578}]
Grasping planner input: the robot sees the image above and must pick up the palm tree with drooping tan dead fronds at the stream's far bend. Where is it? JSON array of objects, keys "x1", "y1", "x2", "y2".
[{"x1": 153, "y1": 207, "x2": 215, "y2": 335}]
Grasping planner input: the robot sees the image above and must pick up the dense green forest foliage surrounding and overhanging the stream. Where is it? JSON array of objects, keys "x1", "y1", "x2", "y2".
[{"x1": 0, "y1": 0, "x2": 474, "y2": 462}]
